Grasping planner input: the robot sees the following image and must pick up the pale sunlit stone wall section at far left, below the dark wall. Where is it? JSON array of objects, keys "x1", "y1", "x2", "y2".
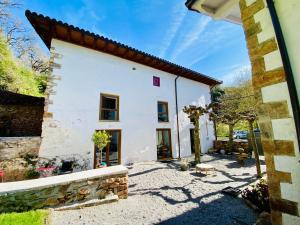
[{"x1": 0, "y1": 137, "x2": 41, "y2": 161}]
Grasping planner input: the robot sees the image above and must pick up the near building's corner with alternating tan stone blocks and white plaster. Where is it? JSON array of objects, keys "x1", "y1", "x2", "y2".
[{"x1": 240, "y1": 0, "x2": 300, "y2": 225}]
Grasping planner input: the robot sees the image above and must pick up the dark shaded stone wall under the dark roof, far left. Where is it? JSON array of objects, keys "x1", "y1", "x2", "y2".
[{"x1": 0, "y1": 104, "x2": 44, "y2": 137}]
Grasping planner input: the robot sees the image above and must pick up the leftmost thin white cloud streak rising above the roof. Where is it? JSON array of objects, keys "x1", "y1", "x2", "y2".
[{"x1": 159, "y1": 2, "x2": 187, "y2": 58}]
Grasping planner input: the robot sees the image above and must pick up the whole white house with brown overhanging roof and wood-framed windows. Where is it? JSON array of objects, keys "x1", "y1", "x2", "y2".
[{"x1": 26, "y1": 11, "x2": 220, "y2": 168}]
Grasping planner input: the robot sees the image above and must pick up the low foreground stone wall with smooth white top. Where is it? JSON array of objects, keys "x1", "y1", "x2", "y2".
[{"x1": 0, "y1": 166, "x2": 128, "y2": 213}]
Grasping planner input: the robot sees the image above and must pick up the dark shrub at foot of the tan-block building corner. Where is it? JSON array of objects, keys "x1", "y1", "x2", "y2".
[{"x1": 242, "y1": 179, "x2": 270, "y2": 212}]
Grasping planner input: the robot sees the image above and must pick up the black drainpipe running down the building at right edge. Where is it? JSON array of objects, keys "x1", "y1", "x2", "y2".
[{"x1": 267, "y1": 0, "x2": 300, "y2": 151}]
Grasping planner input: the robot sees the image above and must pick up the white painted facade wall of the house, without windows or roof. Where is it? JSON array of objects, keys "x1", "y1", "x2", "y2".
[{"x1": 40, "y1": 40, "x2": 214, "y2": 169}]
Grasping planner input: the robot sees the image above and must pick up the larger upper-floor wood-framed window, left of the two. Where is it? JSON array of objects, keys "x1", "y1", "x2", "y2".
[{"x1": 100, "y1": 94, "x2": 119, "y2": 121}]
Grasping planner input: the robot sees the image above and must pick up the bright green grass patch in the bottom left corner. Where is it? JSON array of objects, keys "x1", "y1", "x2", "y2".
[{"x1": 0, "y1": 210, "x2": 49, "y2": 225}]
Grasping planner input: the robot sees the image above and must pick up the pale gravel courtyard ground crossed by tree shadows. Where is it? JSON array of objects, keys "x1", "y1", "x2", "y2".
[{"x1": 51, "y1": 155, "x2": 265, "y2": 225}]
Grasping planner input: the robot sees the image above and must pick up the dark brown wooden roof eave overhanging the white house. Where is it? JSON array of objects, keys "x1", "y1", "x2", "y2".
[{"x1": 25, "y1": 10, "x2": 222, "y2": 86}]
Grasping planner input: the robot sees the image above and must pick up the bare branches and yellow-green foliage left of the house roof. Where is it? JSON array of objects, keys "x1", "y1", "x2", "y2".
[{"x1": 0, "y1": 0, "x2": 50, "y2": 96}]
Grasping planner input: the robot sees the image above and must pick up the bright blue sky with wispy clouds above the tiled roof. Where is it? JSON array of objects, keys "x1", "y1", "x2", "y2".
[{"x1": 15, "y1": 0, "x2": 250, "y2": 84}]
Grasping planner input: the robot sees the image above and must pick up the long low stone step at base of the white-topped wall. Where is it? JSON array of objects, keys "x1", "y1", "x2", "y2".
[{"x1": 54, "y1": 195, "x2": 119, "y2": 211}]
